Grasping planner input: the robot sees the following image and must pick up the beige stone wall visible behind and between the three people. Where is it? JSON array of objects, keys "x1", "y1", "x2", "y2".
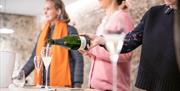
[{"x1": 0, "y1": 0, "x2": 162, "y2": 91}]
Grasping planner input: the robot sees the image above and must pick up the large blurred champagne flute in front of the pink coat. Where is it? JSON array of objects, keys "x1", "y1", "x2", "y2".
[{"x1": 104, "y1": 32, "x2": 125, "y2": 91}]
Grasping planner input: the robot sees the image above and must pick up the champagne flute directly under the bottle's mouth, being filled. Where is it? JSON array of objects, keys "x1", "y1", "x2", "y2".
[{"x1": 41, "y1": 46, "x2": 52, "y2": 88}]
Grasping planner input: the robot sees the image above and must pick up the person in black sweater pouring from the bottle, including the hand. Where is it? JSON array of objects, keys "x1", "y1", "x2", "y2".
[{"x1": 82, "y1": 0, "x2": 180, "y2": 91}]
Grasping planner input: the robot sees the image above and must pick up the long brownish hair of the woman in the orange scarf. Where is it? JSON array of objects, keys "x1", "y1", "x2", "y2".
[{"x1": 46, "y1": 0, "x2": 70, "y2": 23}]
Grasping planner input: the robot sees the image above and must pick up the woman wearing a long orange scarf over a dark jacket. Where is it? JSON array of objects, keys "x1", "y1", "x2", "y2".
[{"x1": 16, "y1": 0, "x2": 84, "y2": 87}]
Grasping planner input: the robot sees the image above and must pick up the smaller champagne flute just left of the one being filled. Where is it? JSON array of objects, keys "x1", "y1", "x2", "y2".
[{"x1": 34, "y1": 56, "x2": 42, "y2": 87}]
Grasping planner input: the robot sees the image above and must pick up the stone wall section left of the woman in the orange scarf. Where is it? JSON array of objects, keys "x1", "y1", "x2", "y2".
[{"x1": 0, "y1": 13, "x2": 40, "y2": 82}]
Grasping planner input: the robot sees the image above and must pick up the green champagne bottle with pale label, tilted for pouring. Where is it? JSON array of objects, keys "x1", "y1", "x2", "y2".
[{"x1": 48, "y1": 35, "x2": 90, "y2": 50}]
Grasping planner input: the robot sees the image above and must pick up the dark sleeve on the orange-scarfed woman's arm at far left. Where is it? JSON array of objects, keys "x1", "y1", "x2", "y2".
[{"x1": 22, "y1": 46, "x2": 36, "y2": 77}]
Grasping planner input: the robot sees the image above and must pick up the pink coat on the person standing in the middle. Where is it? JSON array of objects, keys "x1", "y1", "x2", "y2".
[{"x1": 88, "y1": 10, "x2": 133, "y2": 91}]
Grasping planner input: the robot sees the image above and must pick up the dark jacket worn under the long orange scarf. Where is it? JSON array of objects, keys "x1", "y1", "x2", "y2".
[{"x1": 22, "y1": 25, "x2": 84, "y2": 87}]
